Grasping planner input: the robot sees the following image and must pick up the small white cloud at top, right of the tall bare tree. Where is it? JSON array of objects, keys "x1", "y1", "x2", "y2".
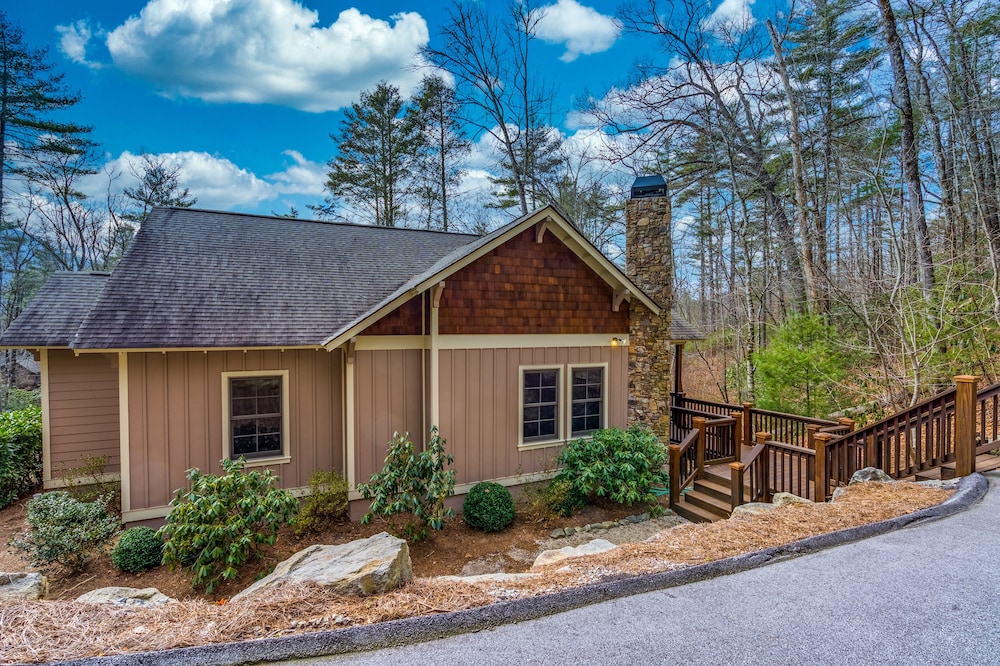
[{"x1": 537, "y1": 0, "x2": 621, "y2": 62}]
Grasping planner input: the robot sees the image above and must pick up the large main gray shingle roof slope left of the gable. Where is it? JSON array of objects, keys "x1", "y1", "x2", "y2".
[{"x1": 72, "y1": 208, "x2": 477, "y2": 349}]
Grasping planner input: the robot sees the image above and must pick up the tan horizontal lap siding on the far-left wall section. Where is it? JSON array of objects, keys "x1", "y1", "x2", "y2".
[{"x1": 45, "y1": 349, "x2": 121, "y2": 479}]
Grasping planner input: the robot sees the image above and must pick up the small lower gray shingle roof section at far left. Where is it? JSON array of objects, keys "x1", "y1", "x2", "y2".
[{"x1": 0, "y1": 273, "x2": 109, "y2": 347}]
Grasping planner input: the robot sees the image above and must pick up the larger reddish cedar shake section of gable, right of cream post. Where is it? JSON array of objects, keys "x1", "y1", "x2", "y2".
[{"x1": 438, "y1": 227, "x2": 629, "y2": 335}]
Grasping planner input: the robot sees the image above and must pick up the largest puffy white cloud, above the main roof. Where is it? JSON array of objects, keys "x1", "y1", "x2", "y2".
[{"x1": 97, "y1": 0, "x2": 429, "y2": 112}]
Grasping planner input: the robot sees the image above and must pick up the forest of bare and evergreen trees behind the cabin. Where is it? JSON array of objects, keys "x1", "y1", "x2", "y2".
[{"x1": 0, "y1": 0, "x2": 1000, "y2": 419}]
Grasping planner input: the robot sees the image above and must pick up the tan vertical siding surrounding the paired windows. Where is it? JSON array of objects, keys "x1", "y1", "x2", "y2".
[{"x1": 439, "y1": 347, "x2": 628, "y2": 484}]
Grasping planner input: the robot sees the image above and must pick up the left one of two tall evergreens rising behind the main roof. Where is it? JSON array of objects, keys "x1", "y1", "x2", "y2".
[{"x1": 313, "y1": 81, "x2": 424, "y2": 227}]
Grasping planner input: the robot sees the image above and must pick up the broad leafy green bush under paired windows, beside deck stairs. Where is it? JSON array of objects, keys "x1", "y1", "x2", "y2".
[{"x1": 556, "y1": 426, "x2": 669, "y2": 506}]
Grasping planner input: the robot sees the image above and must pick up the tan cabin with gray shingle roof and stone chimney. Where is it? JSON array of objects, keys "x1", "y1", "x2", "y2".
[{"x1": 0, "y1": 188, "x2": 698, "y2": 523}]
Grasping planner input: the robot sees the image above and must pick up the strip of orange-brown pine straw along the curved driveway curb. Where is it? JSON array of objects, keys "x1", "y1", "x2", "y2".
[{"x1": 0, "y1": 483, "x2": 951, "y2": 663}]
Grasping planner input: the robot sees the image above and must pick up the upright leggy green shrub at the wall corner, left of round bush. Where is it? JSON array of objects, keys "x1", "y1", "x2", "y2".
[{"x1": 358, "y1": 428, "x2": 455, "y2": 541}]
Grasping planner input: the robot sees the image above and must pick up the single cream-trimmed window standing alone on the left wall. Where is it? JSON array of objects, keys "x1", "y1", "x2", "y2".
[{"x1": 222, "y1": 370, "x2": 288, "y2": 463}]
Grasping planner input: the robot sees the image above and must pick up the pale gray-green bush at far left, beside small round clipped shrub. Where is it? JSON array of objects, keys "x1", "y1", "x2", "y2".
[{"x1": 10, "y1": 491, "x2": 121, "y2": 571}]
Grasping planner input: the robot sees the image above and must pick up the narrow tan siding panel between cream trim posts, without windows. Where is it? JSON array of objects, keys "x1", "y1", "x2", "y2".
[{"x1": 354, "y1": 349, "x2": 429, "y2": 483}]
